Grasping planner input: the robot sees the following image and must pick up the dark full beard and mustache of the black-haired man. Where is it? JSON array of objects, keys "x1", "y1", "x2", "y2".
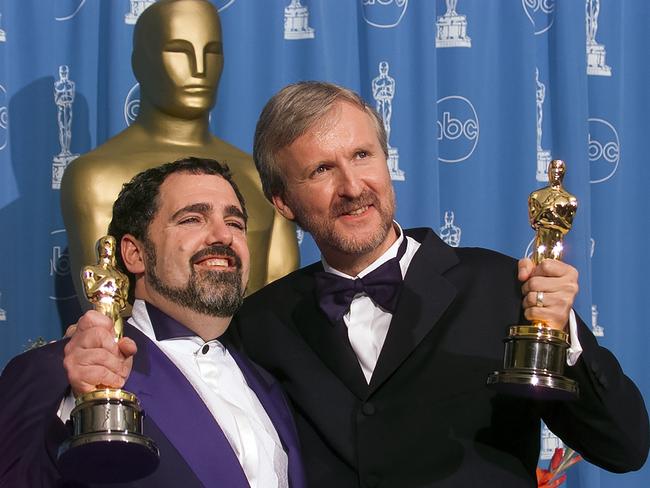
[{"x1": 144, "y1": 239, "x2": 244, "y2": 317}]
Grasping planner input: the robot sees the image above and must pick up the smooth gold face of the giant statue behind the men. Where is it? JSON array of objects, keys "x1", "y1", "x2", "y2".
[{"x1": 134, "y1": 1, "x2": 223, "y2": 119}]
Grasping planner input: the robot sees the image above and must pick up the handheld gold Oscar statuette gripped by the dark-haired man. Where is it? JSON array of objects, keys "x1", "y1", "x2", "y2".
[{"x1": 58, "y1": 236, "x2": 159, "y2": 483}]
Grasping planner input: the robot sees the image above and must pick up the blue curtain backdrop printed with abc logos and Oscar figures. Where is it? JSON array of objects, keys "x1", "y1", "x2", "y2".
[{"x1": 0, "y1": 0, "x2": 650, "y2": 487}]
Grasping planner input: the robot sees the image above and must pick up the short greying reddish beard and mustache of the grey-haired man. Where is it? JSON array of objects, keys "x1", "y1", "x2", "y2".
[{"x1": 289, "y1": 188, "x2": 395, "y2": 254}]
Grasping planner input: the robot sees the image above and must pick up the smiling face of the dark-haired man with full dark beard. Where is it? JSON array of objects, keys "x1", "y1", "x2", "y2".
[{"x1": 144, "y1": 173, "x2": 250, "y2": 317}]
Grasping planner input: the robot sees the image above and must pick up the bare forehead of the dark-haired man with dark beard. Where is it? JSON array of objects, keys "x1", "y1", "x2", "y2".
[{"x1": 158, "y1": 173, "x2": 241, "y2": 214}]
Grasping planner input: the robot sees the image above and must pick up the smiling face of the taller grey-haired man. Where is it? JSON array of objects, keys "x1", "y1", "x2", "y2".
[{"x1": 274, "y1": 102, "x2": 395, "y2": 261}]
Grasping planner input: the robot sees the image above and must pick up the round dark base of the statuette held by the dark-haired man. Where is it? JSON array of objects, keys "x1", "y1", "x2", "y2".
[{"x1": 58, "y1": 388, "x2": 159, "y2": 483}]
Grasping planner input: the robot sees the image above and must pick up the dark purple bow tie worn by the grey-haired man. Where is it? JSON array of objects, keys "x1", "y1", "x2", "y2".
[{"x1": 315, "y1": 236, "x2": 406, "y2": 324}]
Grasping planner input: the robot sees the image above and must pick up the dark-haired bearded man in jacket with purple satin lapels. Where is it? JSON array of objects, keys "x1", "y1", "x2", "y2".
[{"x1": 0, "y1": 158, "x2": 304, "y2": 488}]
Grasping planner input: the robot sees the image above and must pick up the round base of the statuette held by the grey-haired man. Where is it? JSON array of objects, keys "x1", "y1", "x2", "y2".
[{"x1": 487, "y1": 324, "x2": 579, "y2": 401}]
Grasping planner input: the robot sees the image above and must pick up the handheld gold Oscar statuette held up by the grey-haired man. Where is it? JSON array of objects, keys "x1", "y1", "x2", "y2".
[{"x1": 488, "y1": 159, "x2": 578, "y2": 400}]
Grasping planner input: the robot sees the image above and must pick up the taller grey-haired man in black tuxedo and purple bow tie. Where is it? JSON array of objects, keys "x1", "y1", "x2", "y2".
[{"x1": 235, "y1": 82, "x2": 649, "y2": 488}]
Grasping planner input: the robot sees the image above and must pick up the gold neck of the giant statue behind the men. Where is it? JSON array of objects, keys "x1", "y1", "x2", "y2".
[{"x1": 135, "y1": 99, "x2": 211, "y2": 146}]
